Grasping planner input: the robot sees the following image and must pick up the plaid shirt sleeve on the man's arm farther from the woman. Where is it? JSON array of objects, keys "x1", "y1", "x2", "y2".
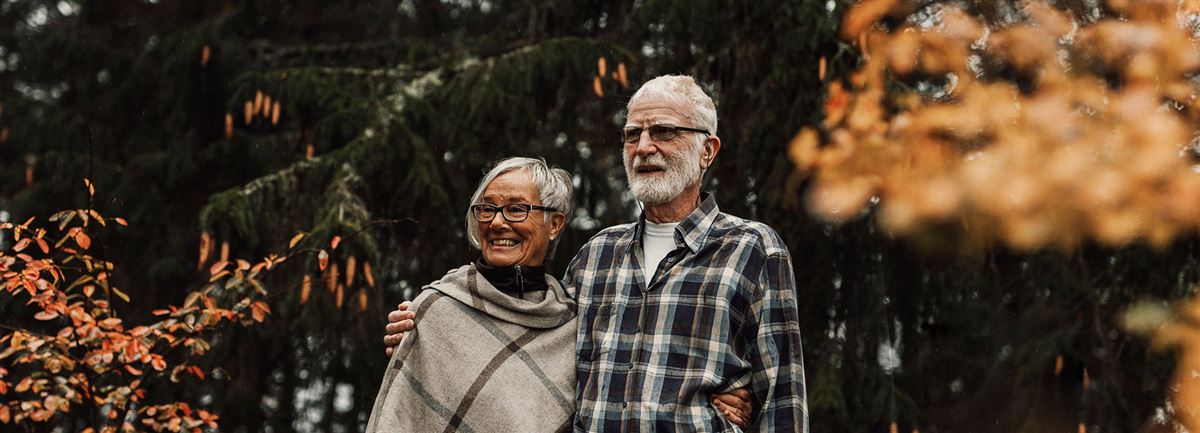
[{"x1": 749, "y1": 253, "x2": 809, "y2": 433}]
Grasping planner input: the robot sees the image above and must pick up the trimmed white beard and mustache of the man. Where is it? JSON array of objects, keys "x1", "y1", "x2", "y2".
[{"x1": 623, "y1": 140, "x2": 703, "y2": 204}]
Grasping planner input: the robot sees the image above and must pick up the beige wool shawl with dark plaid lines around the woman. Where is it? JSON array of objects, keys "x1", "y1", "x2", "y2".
[{"x1": 367, "y1": 265, "x2": 576, "y2": 433}]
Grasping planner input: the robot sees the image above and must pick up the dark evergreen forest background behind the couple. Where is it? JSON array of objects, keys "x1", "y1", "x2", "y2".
[{"x1": 0, "y1": 0, "x2": 1180, "y2": 433}]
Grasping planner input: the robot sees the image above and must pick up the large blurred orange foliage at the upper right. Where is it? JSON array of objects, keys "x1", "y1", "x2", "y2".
[{"x1": 788, "y1": 1, "x2": 1200, "y2": 251}]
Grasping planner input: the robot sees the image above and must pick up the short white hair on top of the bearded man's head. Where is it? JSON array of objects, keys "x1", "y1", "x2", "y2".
[{"x1": 625, "y1": 76, "x2": 716, "y2": 136}]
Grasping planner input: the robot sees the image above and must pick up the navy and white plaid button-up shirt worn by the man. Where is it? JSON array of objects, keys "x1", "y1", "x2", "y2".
[{"x1": 564, "y1": 194, "x2": 808, "y2": 433}]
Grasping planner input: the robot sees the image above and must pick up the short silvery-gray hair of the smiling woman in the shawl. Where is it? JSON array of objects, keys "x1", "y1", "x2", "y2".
[{"x1": 467, "y1": 156, "x2": 575, "y2": 253}]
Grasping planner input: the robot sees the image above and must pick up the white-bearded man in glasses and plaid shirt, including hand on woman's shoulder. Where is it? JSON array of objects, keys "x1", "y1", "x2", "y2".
[{"x1": 385, "y1": 76, "x2": 808, "y2": 432}]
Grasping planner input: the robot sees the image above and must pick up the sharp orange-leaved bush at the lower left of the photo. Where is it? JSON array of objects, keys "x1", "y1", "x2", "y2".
[{"x1": 0, "y1": 199, "x2": 284, "y2": 432}]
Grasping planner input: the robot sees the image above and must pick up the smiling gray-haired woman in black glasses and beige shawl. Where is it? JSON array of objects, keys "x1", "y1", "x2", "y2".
[{"x1": 367, "y1": 157, "x2": 576, "y2": 433}]
